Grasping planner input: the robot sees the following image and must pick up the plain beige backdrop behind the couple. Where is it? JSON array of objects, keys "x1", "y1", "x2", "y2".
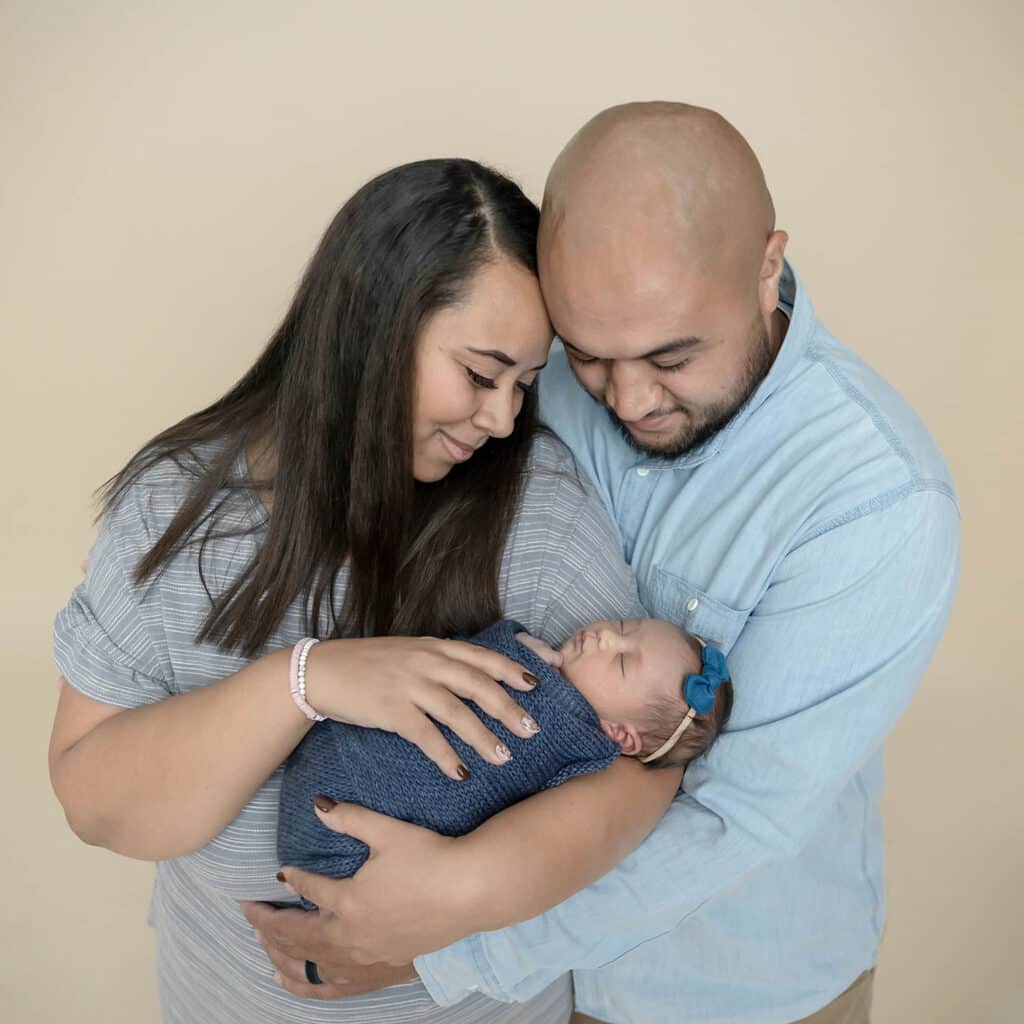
[{"x1": 0, "y1": 0, "x2": 1024, "y2": 1024}]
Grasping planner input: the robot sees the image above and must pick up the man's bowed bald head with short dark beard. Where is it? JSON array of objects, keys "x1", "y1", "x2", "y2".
[{"x1": 538, "y1": 103, "x2": 786, "y2": 456}]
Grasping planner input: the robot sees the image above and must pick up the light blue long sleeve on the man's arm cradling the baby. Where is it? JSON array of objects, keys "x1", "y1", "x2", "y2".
[{"x1": 416, "y1": 490, "x2": 959, "y2": 1006}]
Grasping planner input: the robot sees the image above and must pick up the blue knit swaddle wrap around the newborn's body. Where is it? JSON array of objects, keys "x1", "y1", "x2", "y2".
[{"x1": 278, "y1": 620, "x2": 620, "y2": 879}]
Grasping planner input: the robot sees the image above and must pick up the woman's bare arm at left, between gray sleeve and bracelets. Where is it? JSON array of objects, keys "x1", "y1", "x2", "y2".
[{"x1": 50, "y1": 650, "x2": 310, "y2": 860}]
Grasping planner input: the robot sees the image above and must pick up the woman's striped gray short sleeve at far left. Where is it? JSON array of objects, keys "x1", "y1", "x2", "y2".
[{"x1": 53, "y1": 486, "x2": 174, "y2": 708}]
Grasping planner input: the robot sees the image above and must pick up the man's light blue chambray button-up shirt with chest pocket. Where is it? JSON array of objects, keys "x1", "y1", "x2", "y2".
[{"x1": 416, "y1": 266, "x2": 959, "y2": 1024}]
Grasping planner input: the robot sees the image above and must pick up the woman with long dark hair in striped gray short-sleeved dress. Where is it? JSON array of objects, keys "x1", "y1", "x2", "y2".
[{"x1": 50, "y1": 160, "x2": 669, "y2": 1024}]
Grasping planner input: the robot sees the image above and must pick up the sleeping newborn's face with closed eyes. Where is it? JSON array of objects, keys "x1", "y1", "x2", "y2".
[{"x1": 560, "y1": 618, "x2": 700, "y2": 723}]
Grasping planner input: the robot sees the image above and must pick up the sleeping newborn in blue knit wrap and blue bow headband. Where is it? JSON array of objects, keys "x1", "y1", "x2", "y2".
[{"x1": 278, "y1": 618, "x2": 732, "y2": 878}]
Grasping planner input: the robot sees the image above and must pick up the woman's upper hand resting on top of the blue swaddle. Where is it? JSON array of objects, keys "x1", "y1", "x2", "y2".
[{"x1": 306, "y1": 637, "x2": 540, "y2": 779}]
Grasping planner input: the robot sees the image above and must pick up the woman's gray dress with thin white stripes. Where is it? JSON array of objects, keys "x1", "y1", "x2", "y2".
[{"x1": 54, "y1": 434, "x2": 642, "y2": 1024}]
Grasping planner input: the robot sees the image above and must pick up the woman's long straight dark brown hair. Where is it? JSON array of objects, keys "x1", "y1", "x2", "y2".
[{"x1": 100, "y1": 160, "x2": 539, "y2": 656}]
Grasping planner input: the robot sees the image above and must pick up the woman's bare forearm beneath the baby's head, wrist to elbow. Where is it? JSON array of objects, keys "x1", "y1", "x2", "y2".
[{"x1": 460, "y1": 758, "x2": 682, "y2": 934}]
